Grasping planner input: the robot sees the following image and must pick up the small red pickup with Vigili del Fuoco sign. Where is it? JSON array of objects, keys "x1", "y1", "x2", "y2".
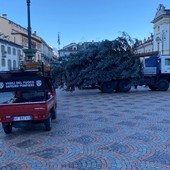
[{"x1": 0, "y1": 61, "x2": 57, "y2": 134}]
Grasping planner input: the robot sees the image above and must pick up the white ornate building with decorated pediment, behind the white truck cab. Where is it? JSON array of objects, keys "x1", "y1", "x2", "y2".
[{"x1": 137, "y1": 4, "x2": 170, "y2": 56}]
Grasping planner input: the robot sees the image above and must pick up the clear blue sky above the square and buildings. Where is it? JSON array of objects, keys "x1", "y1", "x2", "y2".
[{"x1": 0, "y1": 0, "x2": 170, "y2": 48}]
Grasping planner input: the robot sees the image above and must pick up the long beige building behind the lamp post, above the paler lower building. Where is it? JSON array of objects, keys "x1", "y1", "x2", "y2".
[{"x1": 0, "y1": 14, "x2": 53, "y2": 64}]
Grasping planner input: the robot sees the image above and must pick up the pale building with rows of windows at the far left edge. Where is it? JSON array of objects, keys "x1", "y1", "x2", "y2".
[{"x1": 0, "y1": 39, "x2": 22, "y2": 71}]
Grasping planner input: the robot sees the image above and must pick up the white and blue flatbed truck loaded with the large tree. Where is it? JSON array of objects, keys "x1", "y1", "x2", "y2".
[{"x1": 99, "y1": 56, "x2": 170, "y2": 93}]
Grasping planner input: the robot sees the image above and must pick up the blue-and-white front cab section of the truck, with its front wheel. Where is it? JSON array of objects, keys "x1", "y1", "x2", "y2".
[{"x1": 140, "y1": 56, "x2": 170, "y2": 91}]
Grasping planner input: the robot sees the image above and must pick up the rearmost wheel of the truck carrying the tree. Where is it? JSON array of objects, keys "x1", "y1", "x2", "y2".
[{"x1": 99, "y1": 81, "x2": 117, "y2": 93}]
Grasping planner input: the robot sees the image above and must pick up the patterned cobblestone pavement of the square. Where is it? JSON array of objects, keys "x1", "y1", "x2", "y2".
[{"x1": 0, "y1": 88, "x2": 170, "y2": 170}]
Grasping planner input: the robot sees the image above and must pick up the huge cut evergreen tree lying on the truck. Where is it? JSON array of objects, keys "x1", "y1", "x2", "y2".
[{"x1": 53, "y1": 33, "x2": 141, "y2": 91}]
